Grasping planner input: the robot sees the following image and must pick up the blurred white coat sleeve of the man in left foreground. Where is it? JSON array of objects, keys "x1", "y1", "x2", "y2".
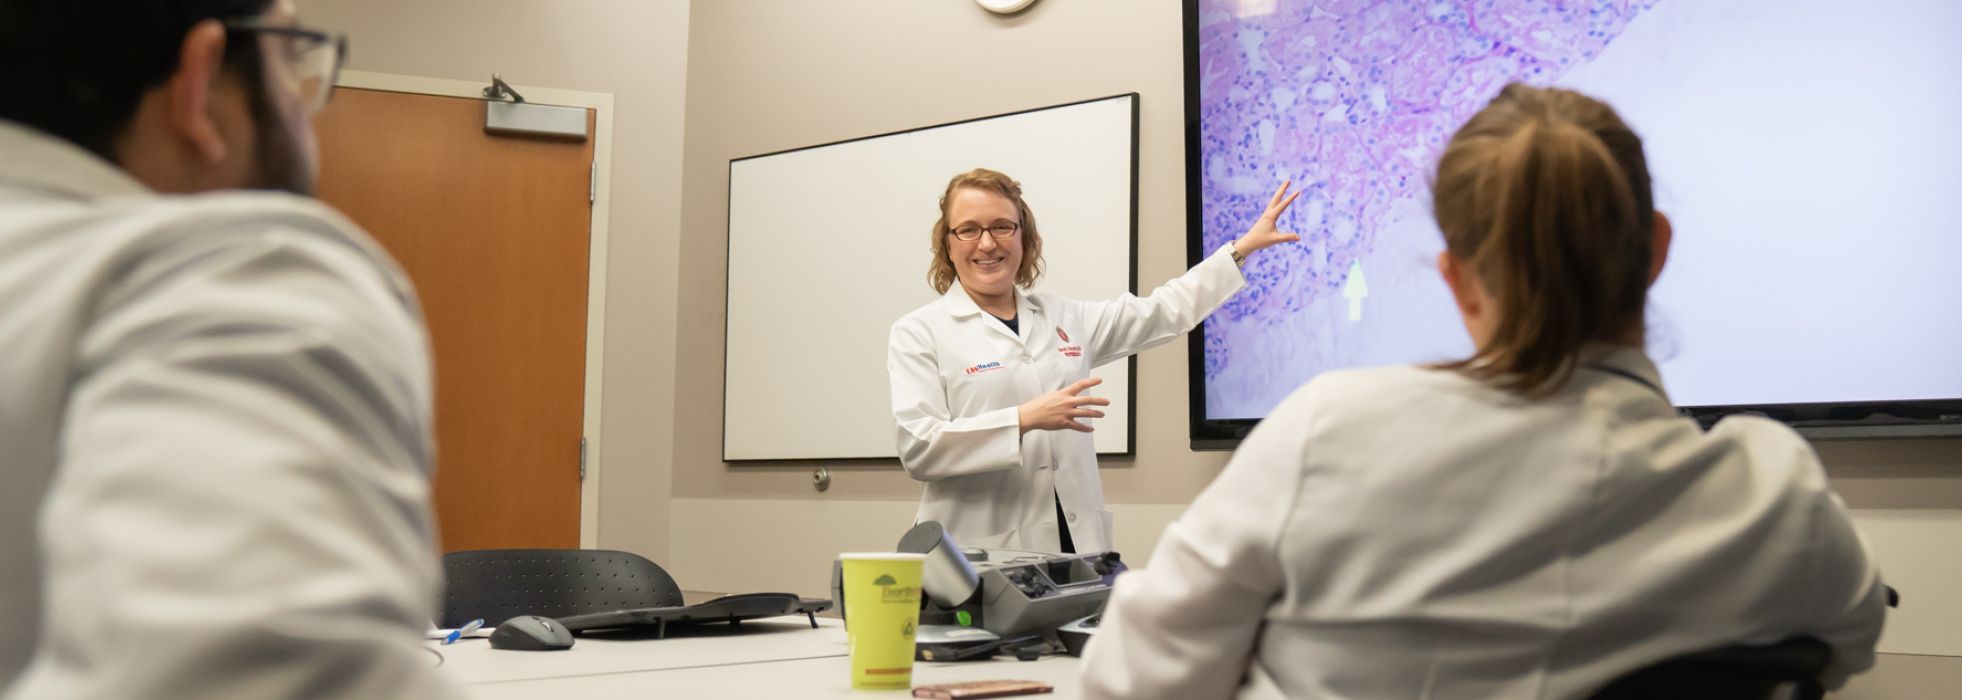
[{"x1": 14, "y1": 215, "x2": 457, "y2": 698}]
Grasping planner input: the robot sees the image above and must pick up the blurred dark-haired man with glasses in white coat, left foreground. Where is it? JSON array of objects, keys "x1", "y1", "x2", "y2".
[{"x1": 0, "y1": 0, "x2": 455, "y2": 700}]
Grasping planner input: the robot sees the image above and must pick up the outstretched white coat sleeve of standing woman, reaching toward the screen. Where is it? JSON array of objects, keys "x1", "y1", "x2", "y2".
[{"x1": 1083, "y1": 247, "x2": 1246, "y2": 367}]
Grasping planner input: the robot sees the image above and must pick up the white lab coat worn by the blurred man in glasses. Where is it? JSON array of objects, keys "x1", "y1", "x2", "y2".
[{"x1": 0, "y1": 122, "x2": 455, "y2": 700}]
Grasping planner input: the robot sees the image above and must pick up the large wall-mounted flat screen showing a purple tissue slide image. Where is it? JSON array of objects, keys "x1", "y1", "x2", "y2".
[{"x1": 1185, "y1": 0, "x2": 1962, "y2": 445}]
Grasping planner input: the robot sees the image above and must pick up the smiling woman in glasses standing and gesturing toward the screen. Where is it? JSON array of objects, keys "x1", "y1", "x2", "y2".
[{"x1": 887, "y1": 169, "x2": 1299, "y2": 553}]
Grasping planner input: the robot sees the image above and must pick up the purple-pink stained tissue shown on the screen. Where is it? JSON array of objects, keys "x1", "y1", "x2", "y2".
[{"x1": 1199, "y1": 0, "x2": 1658, "y2": 409}]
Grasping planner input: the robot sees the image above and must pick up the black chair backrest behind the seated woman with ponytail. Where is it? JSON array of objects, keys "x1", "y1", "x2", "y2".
[{"x1": 1589, "y1": 637, "x2": 1833, "y2": 700}]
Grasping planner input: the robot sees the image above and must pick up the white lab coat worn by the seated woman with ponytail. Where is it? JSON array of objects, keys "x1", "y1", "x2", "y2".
[{"x1": 1083, "y1": 345, "x2": 1885, "y2": 700}]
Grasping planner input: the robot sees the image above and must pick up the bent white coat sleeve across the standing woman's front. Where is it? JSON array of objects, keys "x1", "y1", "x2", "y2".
[{"x1": 885, "y1": 320, "x2": 1022, "y2": 480}]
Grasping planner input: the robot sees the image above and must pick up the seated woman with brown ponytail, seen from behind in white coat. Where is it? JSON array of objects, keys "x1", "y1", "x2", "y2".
[{"x1": 1083, "y1": 84, "x2": 1885, "y2": 698}]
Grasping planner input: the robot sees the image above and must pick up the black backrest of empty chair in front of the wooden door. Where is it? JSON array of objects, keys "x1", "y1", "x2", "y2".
[{"x1": 441, "y1": 549, "x2": 683, "y2": 627}]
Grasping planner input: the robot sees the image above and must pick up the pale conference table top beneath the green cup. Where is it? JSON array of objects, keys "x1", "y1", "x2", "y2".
[{"x1": 428, "y1": 618, "x2": 1081, "y2": 700}]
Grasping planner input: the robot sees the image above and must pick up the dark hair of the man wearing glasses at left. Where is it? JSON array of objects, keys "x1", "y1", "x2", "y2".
[{"x1": 0, "y1": 0, "x2": 273, "y2": 161}]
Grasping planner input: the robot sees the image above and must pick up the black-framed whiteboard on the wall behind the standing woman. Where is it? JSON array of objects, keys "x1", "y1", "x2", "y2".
[{"x1": 722, "y1": 94, "x2": 1138, "y2": 461}]
